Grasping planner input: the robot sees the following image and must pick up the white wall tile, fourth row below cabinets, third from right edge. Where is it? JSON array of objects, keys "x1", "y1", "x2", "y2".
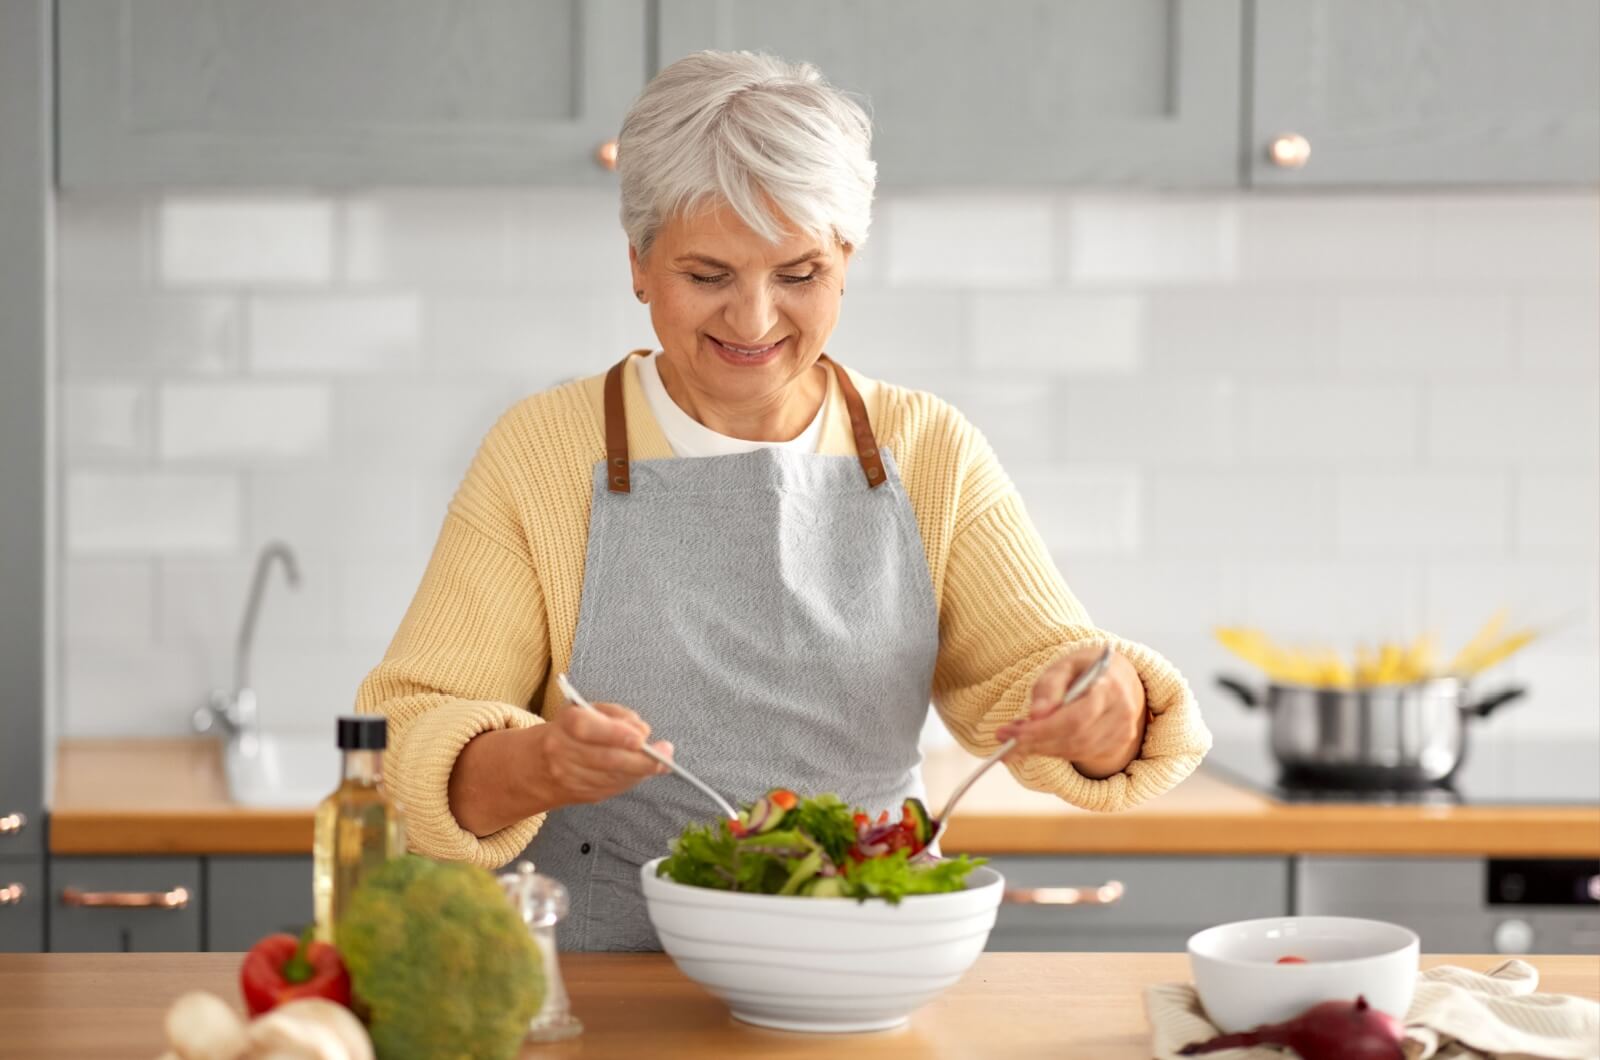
[{"x1": 1142, "y1": 471, "x2": 1333, "y2": 560}]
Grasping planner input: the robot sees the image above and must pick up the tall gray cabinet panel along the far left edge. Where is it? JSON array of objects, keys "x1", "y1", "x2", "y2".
[{"x1": 0, "y1": 0, "x2": 51, "y2": 871}]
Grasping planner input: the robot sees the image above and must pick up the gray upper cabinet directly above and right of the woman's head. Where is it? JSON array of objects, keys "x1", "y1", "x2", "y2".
[{"x1": 658, "y1": 0, "x2": 1242, "y2": 187}]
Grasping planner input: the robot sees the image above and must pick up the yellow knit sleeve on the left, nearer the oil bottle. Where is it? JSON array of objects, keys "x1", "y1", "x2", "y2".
[{"x1": 357, "y1": 422, "x2": 550, "y2": 868}]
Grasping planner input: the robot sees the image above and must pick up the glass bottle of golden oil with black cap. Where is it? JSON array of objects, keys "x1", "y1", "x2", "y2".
[{"x1": 312, "y1": 714, "x2": 405, "y2": 943}]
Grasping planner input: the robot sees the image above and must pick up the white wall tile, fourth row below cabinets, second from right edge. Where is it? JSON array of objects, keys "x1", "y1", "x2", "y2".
[{"x1": 1338, "y1": 472, "x2": 1510, "y2": 557}]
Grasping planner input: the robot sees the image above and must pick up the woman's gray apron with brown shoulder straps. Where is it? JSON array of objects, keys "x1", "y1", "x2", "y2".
[{"x1": 525, "y1": 359, "x2": 939, "y2": 950}]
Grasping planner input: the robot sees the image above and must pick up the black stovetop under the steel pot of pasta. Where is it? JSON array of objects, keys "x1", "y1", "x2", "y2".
[{"x1": 1205, "y1": 733, "x2": 1600, "y2": 805}]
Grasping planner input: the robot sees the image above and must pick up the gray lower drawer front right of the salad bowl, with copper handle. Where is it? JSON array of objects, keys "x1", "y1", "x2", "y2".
[{"x1": 987, "y1": 857, "x2": 1290, "y2": 953}]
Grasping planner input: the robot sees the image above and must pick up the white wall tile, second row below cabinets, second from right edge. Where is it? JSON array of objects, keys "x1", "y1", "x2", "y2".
[{"x1": 1338, "y1": 293, "x2": 1512, "y2": 379}]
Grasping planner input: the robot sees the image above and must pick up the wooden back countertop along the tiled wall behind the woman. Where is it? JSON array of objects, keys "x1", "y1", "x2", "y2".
[{"x1": 50, "y1": 740, "x2": 1600, "y2": 857}]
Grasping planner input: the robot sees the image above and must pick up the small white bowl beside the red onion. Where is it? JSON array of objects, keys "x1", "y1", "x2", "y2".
[{"x1": 1189, "y1": 916, "x2": 1419, "y2": 1033}]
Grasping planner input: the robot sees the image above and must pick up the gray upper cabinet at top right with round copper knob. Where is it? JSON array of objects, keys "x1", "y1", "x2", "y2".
[{"x1": 1248, "y1": 0, "x2": 1600, "y2": 186}]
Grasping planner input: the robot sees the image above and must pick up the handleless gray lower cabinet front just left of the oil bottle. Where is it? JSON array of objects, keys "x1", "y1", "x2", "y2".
[{"x1": 205, "y1": 857, "x2": 312, "y2": 951}]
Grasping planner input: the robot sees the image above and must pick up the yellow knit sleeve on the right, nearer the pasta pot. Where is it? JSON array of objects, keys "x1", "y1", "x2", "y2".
[{"x1": 933, "y1": 439, "x2": 1211, "y2": 810}]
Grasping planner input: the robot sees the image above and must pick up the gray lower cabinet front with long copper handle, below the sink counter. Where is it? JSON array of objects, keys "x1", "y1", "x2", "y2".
[{"x1": 48, "y1": 858, "x2": 205, "y2": 953}]
